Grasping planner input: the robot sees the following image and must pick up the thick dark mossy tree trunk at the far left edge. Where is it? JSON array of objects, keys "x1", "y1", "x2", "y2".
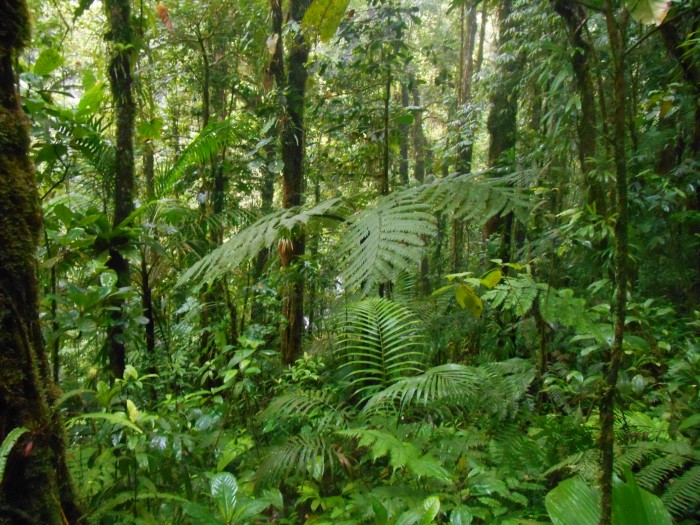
[{"x1": 0, "y1": 0, "x2": 80, "y2": 525}]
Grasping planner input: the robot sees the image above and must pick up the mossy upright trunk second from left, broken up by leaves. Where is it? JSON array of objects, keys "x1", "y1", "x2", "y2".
[{"x1": 104, "y1": 0, "x2": 136, "y2": 379}]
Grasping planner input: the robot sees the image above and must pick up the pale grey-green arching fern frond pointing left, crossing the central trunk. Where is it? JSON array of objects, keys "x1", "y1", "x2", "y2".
[{"x1": 177, "y1": 199, "x2": 347, "y2": 286}]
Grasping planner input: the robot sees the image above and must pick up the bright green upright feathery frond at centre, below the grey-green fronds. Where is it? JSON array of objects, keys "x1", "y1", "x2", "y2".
[{"x1": 338, "y1": 298, "x2": 425, "y2": 397}]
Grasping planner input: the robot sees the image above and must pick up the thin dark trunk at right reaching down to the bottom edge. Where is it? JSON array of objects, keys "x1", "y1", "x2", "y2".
[{"x1": 599, "y1": 5, "x2": 628, "y2": 525}]
